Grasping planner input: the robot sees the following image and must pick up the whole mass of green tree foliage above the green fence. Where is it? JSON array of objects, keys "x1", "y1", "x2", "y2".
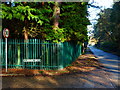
[{"x1": 2, "y1": 2, "x2": 90, "y2": 42}]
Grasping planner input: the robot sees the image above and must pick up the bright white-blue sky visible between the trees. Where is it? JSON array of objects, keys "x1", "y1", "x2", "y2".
[{"x1": 88, "y1": 0, "x2": 113, "y2": 35}]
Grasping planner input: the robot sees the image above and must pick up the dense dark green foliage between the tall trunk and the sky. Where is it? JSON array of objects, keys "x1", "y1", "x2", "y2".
[{"x1": 60, "y1": 3, "x2": 90, "y2": 42}]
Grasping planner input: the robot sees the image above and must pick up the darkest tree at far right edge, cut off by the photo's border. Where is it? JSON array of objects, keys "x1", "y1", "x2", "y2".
[{"x1": 110, "y1": 1, "x2": 120, "y2": 49}]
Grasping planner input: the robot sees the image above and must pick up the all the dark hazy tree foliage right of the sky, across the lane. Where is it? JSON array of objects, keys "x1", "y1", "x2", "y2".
[{"x1": 95, "y1": 2, "x2": 120, "y2": 49}]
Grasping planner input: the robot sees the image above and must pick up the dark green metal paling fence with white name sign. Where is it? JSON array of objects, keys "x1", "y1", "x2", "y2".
[{"x1": 0, "y1": 39, "x2": 81, "y2": 70}]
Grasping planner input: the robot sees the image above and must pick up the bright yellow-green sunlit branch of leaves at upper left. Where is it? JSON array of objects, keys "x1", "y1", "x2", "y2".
[{"x1": 2, "y1": 4, "x2": 42, "y2": 22}]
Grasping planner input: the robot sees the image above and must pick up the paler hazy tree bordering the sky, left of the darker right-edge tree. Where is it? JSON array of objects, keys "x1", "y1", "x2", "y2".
[{"x1": 94, "y1": 8, "x2": 113, "y2": 42}]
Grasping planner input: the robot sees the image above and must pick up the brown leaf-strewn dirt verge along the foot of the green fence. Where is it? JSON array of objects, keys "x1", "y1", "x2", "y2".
[{"x1": 2, "y1": 49, "x2": 101, "y2": 76}]
